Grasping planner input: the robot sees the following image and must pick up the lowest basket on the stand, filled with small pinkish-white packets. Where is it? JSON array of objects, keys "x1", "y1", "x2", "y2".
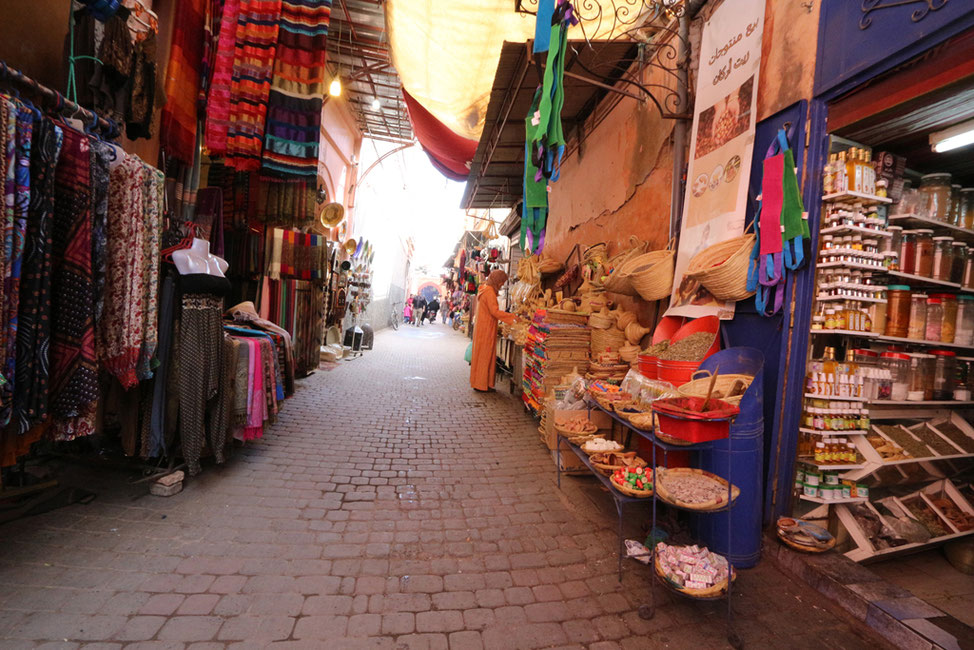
[{"x1": 655, "y1": 542, "x2": 737, "y2": 600}]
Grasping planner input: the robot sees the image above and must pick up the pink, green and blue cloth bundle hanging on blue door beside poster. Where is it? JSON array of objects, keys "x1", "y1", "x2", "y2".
[{"x1": 747, "y1": 129, "x2": 809, "y2": 316}]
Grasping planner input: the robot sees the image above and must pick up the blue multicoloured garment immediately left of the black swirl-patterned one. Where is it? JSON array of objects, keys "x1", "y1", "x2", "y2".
[{"x1": 0, "y1": 105, "x2": 34, "y2": 426}]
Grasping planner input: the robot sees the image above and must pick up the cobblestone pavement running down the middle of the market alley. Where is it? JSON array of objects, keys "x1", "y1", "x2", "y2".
[{"x1": 0, "y1": 325, "x2": 879, "y2": 650}]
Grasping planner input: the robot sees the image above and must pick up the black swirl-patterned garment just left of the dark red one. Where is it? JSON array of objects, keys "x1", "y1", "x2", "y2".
[{"x1": 12, "y1": 119, "x2": 64, "y2": 435}]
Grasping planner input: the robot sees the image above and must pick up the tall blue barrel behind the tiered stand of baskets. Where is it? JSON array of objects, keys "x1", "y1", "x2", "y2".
[{"x1": 692, "y1": 347, "x2": 764, "y2": 569}]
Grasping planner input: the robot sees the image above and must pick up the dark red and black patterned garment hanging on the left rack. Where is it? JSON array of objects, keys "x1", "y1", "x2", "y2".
[{"x1": 50, "y1": 128, "x2": 98, "y2": 420}]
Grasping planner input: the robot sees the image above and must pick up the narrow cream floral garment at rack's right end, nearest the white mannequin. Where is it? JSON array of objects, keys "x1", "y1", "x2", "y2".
[{"x1": 137, "y1": 165, "x2": 166, "y2": 380}]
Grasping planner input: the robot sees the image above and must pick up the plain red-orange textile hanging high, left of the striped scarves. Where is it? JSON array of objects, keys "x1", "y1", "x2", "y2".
[{"x1": 160, "y1": 0, "x2": 207, "y2": 163}]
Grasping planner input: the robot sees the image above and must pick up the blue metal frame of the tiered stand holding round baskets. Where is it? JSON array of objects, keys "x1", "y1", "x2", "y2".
[{"x1": 555, "y1": 403, "x2": 742, "y2": 648}]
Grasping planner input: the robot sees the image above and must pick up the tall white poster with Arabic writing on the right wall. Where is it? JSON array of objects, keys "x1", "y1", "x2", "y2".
[{"x1": 666, "y1": 0, "x2": 765, "y2": 319}]
